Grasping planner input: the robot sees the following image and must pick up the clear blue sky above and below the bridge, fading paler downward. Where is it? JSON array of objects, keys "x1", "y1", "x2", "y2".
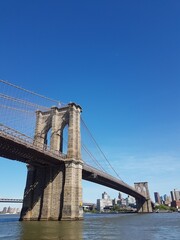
[{"x1": 0, "y1": 0, "x2": 180, "y2": 208}]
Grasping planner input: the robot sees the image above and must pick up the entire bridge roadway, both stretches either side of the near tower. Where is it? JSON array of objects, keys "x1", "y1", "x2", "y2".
[{"x1": 0, "y1": 124, "x2": 146, "y2": 199}]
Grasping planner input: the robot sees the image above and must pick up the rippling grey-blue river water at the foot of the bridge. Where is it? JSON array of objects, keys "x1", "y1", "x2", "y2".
[{"x1": 0, "y1": 213, "x2": 180, "y2": 240}]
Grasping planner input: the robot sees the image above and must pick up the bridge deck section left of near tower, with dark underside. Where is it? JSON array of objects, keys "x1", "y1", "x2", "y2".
[{"x1": 0, "y1": 124, "x2": 66, "y2": 166}]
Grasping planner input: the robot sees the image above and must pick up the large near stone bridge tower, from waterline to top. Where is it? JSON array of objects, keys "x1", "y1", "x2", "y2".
[{"x1": 20, "y1": 103, "x2": 83, "y2": 220}]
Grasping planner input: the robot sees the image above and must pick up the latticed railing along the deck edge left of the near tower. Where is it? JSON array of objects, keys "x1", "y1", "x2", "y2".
[{"x1": 0, "y1": 123, "x2": 67, "y2": 159}]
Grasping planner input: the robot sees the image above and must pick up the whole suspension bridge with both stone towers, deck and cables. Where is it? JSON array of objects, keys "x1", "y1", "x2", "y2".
[{"x1": 0, "y1": 80, "x2": 152, "y2": 220}]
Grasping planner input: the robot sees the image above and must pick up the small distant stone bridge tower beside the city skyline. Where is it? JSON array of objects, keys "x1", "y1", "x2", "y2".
[{"x1": 134, "y1": 182, "x2": 152, "y2": 213}]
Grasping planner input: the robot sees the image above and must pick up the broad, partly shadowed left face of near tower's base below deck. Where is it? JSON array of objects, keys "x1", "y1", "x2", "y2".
[{"x1": 20, "y1": 164, "x2": 64, "y2": 220}]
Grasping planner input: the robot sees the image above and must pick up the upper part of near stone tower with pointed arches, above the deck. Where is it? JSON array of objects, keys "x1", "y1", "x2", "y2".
[{"x1": 34, "y1": 103, "x2": 82, "y2": 159}]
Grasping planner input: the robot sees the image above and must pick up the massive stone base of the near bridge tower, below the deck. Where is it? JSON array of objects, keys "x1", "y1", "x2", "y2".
[{"x1": 20, "y1": 161, "x2": 83, "y2": 221}]
